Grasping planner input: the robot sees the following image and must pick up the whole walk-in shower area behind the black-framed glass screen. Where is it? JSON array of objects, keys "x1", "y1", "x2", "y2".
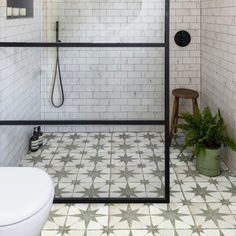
[{"x1": 0, "y1": 0, "x2": 169, "y2": 202}]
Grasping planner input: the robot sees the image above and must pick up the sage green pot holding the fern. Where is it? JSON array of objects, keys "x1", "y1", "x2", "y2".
[{"x1": 197, "y1": 148, "x2": 221, "y2": 177}]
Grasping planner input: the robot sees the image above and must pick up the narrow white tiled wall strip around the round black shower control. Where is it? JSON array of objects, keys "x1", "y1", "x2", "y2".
[{"x1": 170, "y1": 0, "x2": 201, "y2": 111}]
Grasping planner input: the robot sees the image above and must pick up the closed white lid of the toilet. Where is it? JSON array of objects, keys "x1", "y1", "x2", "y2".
[{"x1": 0, "y1": 167, "x2": 54, "y2": 226}]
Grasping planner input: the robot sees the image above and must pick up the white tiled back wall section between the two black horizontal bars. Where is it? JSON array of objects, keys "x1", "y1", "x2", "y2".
[{"x1": 42, "y1": 48, "x2": 164, "y2": 120}]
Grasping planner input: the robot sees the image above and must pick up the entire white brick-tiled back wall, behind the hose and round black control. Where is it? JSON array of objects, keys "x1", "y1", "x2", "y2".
[{"x1": 41, "y1": 0, "x2": 200, "y2": 131}]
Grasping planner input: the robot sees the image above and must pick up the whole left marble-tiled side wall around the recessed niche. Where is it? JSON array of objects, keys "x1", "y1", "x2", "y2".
[{"x1": 0, "y1": 0, "x2": 41, "y2": 166}]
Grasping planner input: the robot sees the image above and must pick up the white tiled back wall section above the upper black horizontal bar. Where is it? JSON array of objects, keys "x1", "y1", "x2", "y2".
[{"x1": 43, "y1": 0, "x2": 165, "y2": 43}]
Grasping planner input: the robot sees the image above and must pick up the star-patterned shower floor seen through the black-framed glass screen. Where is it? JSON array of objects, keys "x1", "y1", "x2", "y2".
[{"x1": 21, "y1": 132, "x2": 165, "y2": 198}]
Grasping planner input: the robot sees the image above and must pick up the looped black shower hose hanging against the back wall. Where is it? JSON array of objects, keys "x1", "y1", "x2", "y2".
[{"x1": 51, "y1": 47, "x2": 65, "y2": 108}]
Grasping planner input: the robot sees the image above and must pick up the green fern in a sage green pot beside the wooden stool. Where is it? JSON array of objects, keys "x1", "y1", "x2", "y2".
[{"x1": 177, "y1": 107, "x2": 236, "y2": 176}]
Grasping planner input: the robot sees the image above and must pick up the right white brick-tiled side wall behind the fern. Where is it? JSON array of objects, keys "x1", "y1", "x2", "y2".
[{"x1": 201, "y1": 0, "x2": 236, "y2": 173}]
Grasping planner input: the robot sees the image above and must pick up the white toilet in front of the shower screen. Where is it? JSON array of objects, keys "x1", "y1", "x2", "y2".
[{"x1": 0, "y1": 167, "x2": 54, "y2": 236}]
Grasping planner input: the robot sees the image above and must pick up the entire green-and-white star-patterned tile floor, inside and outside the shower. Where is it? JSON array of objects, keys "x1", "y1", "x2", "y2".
[{"x1": 22, "y1": 133, "x2": 236, "y2": 236}]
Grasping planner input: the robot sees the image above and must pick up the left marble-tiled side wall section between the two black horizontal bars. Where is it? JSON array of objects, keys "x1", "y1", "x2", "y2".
[{"x1": 0, "y1": 48, "x2": 41, "y2": 121}]
